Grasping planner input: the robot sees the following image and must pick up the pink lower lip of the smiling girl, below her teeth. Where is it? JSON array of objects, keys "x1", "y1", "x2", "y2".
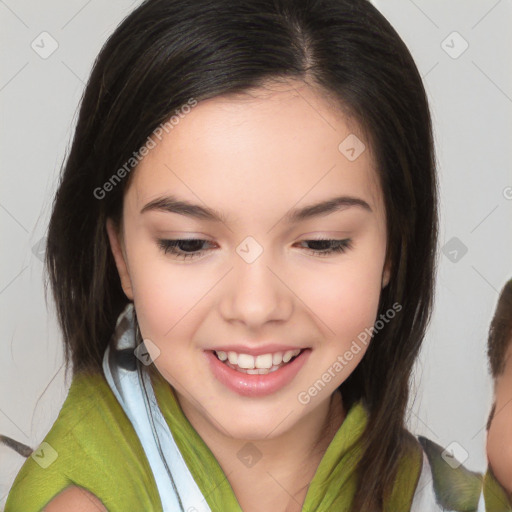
[{"x1": 205, "y1": 349, "x2": 311, "y2": 397}]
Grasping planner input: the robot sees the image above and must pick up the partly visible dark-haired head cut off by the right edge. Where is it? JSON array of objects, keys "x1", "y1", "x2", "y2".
[{"x1": 487, "y1": 279, "x2": 512, "y2": 493}]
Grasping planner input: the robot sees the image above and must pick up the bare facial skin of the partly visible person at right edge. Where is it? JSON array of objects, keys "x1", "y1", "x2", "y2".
[{"x1": 487, "y1": 340, "x2": 512, "y2": 497}]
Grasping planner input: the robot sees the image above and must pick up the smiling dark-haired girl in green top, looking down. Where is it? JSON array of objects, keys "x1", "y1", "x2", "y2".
[{"x1": 6, "y1": 0, "x2": 506, "y2": 512}]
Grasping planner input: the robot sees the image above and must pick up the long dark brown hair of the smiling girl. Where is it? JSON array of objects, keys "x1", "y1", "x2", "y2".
[{"x1": 45, "y1": 0, "x2": 438, "y2": 510}]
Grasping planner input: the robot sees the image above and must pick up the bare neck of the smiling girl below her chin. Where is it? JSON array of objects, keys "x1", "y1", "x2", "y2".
[{"x1": 177, "y1": 391, "x2": 346, "y2": 512}]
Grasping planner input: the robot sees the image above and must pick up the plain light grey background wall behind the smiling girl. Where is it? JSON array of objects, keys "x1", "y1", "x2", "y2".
[{"x1": 0, "y1": 0, "x2": 512, "y2": 509}]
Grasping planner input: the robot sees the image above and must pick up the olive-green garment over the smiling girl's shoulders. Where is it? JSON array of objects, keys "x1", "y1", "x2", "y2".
[{"x1": 5, "y1": 371, "x2": 512, "y2": 512}]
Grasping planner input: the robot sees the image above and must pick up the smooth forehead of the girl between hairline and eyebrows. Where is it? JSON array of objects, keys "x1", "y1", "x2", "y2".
[{"x1": 128, "y1": 82, "x2": 382, "y2": 221}]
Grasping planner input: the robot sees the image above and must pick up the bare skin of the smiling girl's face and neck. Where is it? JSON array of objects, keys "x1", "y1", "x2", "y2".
[{"x1": 107, "y1": 82, "x2": 389, "y2": 512}]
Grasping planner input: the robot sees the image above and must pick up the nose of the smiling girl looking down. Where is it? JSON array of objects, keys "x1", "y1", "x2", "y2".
[{"x1": 220, "y1": 243, "x2": 294, "y2": 330}]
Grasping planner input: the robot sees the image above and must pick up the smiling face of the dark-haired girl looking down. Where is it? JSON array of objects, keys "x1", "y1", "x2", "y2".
[{"x1": 108, "y1": 80, "x2": 388, "y2": 440}]
